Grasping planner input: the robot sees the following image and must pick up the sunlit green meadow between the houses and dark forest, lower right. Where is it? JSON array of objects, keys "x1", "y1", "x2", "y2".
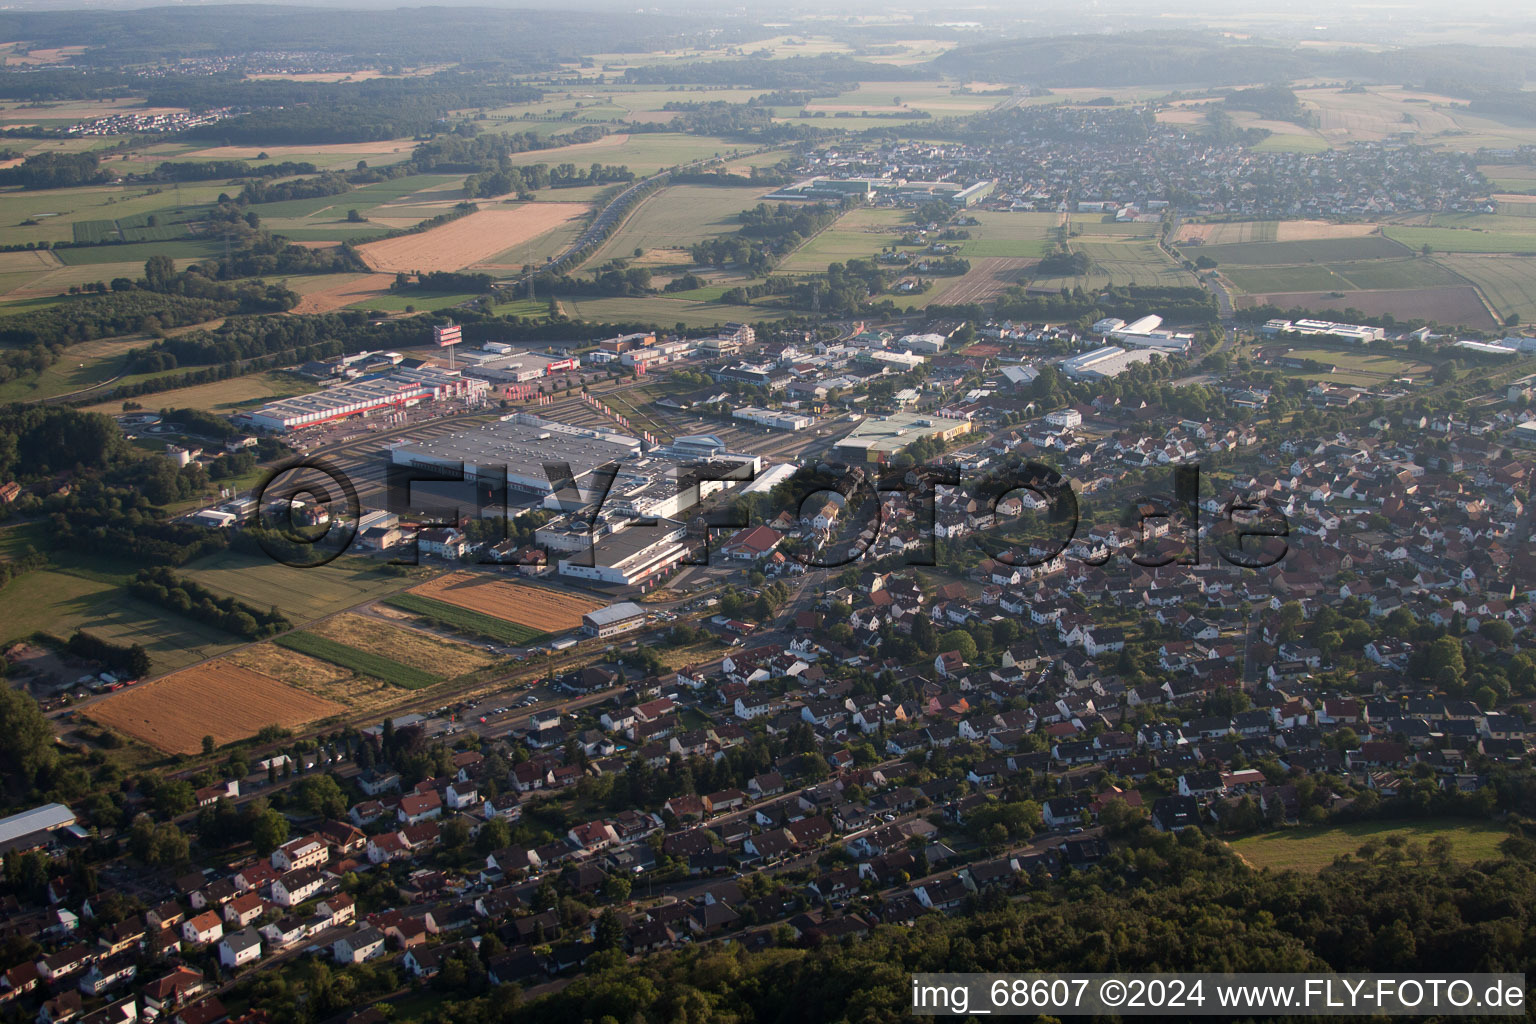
[{"x1": 1232, "y1": 818, "x2": 1508, "y2": 874}]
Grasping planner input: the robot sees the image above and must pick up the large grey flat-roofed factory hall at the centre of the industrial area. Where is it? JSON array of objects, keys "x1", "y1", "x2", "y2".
[{"x1": 390, "y1": 413, "x2": 641, "y2": 494}]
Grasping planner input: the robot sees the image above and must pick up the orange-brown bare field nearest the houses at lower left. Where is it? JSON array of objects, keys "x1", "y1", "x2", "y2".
[{"x1": 86, "y1": 660, "x2": 346, "y2": 754}]
